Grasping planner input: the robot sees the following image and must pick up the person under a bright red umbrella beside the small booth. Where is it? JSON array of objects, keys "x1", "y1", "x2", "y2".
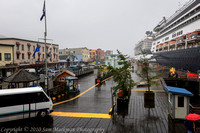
[{"x1": 185, "y1": 113, "x2": 200, "y2": 133}]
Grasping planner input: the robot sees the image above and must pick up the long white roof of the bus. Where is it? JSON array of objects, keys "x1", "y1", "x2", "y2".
[{"x1": 0, "y1": 86, "x2": 43, "y2": 95}]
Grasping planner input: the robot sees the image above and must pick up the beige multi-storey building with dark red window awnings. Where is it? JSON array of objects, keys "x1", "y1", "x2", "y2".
[{"x1": 0, "y1": 38, "x2": 59, "y2": 65}]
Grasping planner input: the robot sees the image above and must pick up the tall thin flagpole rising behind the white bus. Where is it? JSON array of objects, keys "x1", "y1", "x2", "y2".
[{"x1": 44, "y1": 0, "x2": 48, "y2": 91}]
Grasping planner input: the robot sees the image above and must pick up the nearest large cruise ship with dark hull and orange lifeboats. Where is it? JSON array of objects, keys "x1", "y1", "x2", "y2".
[{"x1": 151, "y1": 0, "x2": 200, "y2": 73}]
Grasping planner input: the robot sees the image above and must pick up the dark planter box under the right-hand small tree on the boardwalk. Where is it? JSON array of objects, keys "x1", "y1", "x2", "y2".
[{"x1": 144, "y1": 91, "x2": 155, "y2": 108}]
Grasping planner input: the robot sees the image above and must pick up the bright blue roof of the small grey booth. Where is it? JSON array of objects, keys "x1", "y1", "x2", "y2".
[{"x1": 165, "y1": 86, "x2": 193, "y2": 96}]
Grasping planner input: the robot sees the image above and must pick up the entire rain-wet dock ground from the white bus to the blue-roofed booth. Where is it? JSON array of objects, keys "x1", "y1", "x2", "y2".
[{"x1": 0, "y1": 69, "x2": 189, "y2": 133}]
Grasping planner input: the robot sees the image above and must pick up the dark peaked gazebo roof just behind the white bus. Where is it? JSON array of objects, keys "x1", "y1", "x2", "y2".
[{"x1": 5, "y1": 69, "x2": 40, "y2": 83}]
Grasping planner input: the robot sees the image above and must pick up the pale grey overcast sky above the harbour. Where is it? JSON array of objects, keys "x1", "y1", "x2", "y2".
[{"x1": 0, "y1": 0, "x2": 188, "y2": 56}]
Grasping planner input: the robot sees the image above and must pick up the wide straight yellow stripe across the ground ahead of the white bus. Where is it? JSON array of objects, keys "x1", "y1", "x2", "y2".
[{"x1": 50, "y1": 112, "x2": 111, "y2": 119}]
